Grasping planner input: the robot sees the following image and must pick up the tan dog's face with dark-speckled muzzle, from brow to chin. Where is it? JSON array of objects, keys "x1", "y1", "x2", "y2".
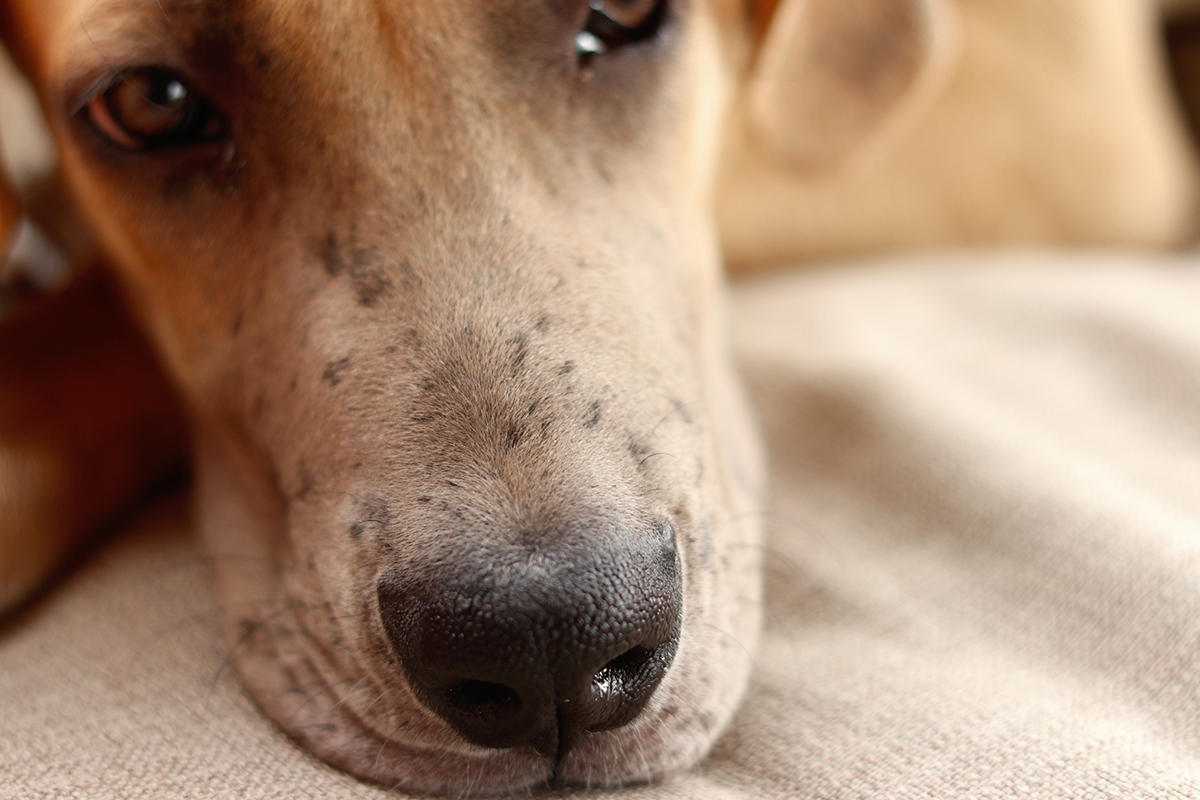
[{"x1": 6, "y1": 0, "x2": 758, "y2": 794}]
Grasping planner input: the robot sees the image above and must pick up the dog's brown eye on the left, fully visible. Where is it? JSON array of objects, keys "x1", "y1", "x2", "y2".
[{"x1": 85, "y1": 67, "x2": 226, "y2": 150}]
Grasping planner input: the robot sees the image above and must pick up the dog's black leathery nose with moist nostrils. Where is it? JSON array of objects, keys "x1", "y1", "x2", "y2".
[{"x1": 378, "y1": 524, "x2": 683, "y2": 758}]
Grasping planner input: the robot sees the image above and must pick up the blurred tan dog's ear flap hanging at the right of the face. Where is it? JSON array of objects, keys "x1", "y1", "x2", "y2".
[{"x1": 746, "y1": 0, "x2": 959, "y2": 172}]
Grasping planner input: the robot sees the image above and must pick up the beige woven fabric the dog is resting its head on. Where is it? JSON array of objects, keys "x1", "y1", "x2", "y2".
[{"x1": 0, "y1": 248, "x2": 1200, "y2": 800}]
